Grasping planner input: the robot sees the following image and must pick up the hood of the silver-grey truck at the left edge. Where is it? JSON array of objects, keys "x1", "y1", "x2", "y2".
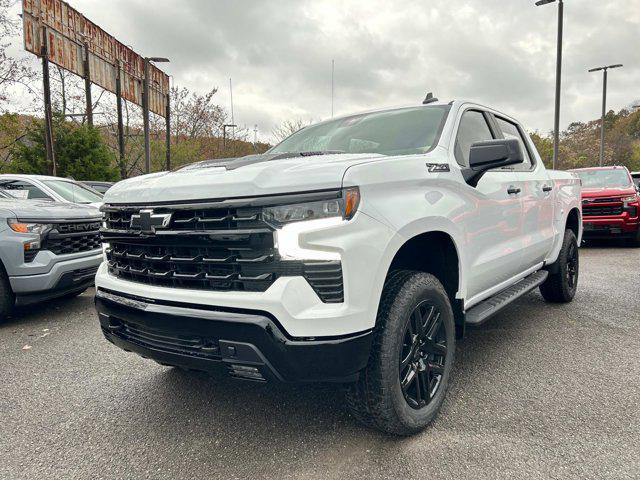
[{"x1": 0, "y1": 198, "x2": 100, "y2": 221}]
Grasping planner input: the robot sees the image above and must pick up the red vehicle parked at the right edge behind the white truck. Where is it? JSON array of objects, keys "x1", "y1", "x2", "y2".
[{"x1": 572, "y1": 167, "x2": 640, "y2": 247}]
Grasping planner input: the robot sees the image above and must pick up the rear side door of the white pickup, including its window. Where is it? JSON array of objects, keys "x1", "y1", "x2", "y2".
[{"x1": 494, "y1": 115, "x2": 554, "y2": 270}]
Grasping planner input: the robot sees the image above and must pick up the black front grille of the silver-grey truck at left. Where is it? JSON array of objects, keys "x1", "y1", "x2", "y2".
[{"x1": 41, "y1": 221, "x2": 100, "y2": 255}]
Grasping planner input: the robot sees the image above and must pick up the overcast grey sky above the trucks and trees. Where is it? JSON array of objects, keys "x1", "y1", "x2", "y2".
[{"x1": 6, "y1": 0, "x2": 640, "y2": 142}]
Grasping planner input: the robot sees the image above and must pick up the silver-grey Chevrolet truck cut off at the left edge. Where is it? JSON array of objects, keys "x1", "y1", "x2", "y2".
[{"x1": 0, "y1": 189, "x2": 102, "y2": 321}]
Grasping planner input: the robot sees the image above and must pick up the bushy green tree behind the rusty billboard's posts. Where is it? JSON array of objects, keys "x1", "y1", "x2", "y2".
[{"x1": 7, "y1": 117, "x2": 120, "y2": 181}]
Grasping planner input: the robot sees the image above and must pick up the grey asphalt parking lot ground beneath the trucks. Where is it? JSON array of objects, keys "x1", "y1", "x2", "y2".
[{"x1": 0, "y1": 245, "x2": 640, "y2": 479}]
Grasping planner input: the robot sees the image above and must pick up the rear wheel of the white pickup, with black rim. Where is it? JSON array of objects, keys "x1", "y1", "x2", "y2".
[{"x1": 540, "y1": 230, "x2": 580, "y2": 303}]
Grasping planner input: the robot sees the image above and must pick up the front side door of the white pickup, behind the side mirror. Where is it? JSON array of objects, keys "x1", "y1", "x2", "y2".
[{"x1": 454, "y1": 108, "x2": 522, "y2": 299}]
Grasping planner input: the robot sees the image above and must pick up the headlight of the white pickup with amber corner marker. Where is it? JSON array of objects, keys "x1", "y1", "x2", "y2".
[{"x1": 262, "y1": 187, "x2": 360, "y2": 228}]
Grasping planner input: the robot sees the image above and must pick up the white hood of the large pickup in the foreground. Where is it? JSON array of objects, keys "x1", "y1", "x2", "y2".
[{"x1": 104, "y1": 153, "x2": 386, "y2": 204}]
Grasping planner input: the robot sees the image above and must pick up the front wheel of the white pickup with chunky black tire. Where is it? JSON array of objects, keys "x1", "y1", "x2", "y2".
[{"x1": 347, "y1": 270, "x2": 455, "y2": 435}]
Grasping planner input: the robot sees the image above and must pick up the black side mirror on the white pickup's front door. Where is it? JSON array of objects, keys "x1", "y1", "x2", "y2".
[{"x1": 464, "y1": 138, "x2": 524, "y2": 187}]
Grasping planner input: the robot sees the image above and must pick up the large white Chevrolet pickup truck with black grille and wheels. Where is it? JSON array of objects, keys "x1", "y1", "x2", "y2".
[{"x1": 95, "y1": 98, "x2": 582, "y2": 435}]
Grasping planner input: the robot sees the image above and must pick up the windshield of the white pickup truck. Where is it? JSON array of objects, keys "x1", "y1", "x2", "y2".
[{"x1": 269, "y1": 105, "x2": 449, "y2": 155}]
